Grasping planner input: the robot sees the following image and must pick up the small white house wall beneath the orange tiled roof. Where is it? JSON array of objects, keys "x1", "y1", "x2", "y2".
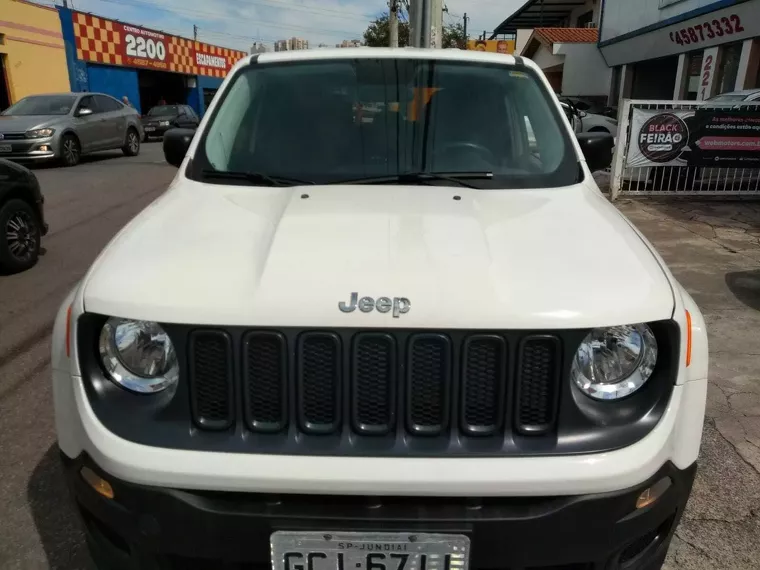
[{"x1": 554, "y1": 44, "x2": 612, "y2": 97}]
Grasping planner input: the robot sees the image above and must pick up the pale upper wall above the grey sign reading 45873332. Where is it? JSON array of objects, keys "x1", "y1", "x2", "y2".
[{"x1": 602, "y1": 0, "x2": 732, "y2": 41}]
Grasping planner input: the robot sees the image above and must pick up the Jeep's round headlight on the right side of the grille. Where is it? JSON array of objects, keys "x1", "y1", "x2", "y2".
[{"x1": 570, "y1": 324, "x2": 657, "y2": 400}]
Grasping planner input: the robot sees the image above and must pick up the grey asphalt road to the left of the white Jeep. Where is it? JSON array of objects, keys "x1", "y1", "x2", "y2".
[{"x1": 0, "y1": 143, "x2": 176, "y2": 570}]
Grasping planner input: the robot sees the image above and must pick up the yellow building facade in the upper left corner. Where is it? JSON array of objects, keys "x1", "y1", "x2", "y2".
[{"x1": 0, "y1": 0, "x2": 69, "y2": 111}]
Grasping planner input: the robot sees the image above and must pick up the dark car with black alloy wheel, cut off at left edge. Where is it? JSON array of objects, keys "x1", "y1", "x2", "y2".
[{"x1": 0, "y1": 155, "x2": 48, "y2": 273}]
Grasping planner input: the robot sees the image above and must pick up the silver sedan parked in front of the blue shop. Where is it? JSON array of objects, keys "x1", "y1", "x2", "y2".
[{"x1": 0, "y1": 93, "x2": 143, "y2": 166}]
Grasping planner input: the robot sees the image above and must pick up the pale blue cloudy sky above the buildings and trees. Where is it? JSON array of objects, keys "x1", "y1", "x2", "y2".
[{"x1": 36, "y1": 0, "x2": 525, "y2": 51}]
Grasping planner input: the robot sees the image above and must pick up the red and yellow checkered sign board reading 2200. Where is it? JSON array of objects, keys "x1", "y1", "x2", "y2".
[{"x1": 73, "y1": 12, "x2": 246, "y2": 77}]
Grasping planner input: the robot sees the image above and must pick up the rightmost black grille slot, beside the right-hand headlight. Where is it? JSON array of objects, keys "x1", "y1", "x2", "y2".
[{"x1": 517, "y1": 336, "x2": 560, "y2": 435}]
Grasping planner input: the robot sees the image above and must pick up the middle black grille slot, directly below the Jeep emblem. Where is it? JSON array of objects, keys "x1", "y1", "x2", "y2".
[{"x1": 351, "y1": 333, "x2": 398, "y2": 435}]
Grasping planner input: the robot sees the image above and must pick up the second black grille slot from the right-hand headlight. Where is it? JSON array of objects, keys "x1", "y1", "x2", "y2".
[{"x1": 460, "y1": 335, "x2": 507, "y2": 435}]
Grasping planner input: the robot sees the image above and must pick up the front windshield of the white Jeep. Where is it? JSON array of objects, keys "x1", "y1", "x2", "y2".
[{"x1": 190, "y1": 58, "x2": 579, "y2": 188}]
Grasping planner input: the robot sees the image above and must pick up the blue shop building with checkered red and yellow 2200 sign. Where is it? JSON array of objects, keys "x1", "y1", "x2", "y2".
[{"x1": 58, "y1": 8, "x2": 247, "y2": 115}]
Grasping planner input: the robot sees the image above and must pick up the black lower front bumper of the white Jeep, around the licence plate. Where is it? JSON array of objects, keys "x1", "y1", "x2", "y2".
[{"x1": 62, "y1": 454, "x2": 696, "y2": 570}]
